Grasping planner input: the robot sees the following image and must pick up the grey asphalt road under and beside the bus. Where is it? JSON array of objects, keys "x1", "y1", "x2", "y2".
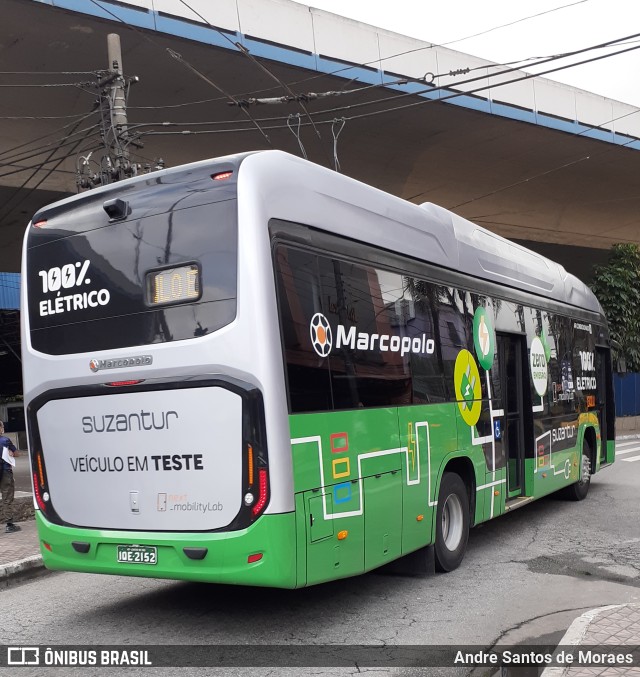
[{"x1": 0, "y1": 440, "x2": 640, "y2": 677}]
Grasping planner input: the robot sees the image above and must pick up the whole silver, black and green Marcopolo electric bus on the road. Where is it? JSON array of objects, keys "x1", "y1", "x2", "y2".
[{"x1": 22, "y1": 151, "x2": 615, "y2": 588}]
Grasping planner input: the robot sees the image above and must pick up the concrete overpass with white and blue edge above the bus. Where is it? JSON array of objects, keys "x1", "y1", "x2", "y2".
[{"x1": 0, "y1": 0, "x2": 640, "y2": 288}]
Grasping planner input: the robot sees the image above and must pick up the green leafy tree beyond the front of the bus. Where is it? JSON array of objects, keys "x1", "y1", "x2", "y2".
[{"x1": 591, "y1": 243, "x2": 640, "y2": 372}]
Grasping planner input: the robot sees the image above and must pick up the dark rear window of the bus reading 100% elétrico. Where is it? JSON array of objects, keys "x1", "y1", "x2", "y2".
[{"x1": 27, "y1": 191, "x2": 238, "y2": 355}]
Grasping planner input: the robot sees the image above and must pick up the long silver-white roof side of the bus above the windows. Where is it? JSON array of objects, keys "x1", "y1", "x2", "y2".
[{"x1": 238, "y1": 151, "x2": 602, "y2": 313}]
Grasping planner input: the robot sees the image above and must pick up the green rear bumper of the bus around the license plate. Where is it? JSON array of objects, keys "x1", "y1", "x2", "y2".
[{"x1": 36, "y1": 510, "x2": 296, "y2": 588}]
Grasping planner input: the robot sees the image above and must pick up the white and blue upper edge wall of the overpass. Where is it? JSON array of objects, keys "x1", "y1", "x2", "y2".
[{"x1": 71, "y1": 0, "x2": 640, "y2": 141}]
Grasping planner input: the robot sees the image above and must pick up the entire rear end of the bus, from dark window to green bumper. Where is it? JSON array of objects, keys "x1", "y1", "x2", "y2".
[{"x1": 22, "y1": 156, "x2": 296, "y2": 587}]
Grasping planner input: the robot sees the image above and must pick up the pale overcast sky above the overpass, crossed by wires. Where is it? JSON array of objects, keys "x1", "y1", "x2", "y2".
[{"x1": 294, "y1": 0, "x2": 640, "y2": 106}]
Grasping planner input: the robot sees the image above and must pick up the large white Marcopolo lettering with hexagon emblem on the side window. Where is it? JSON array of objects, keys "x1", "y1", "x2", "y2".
[{"x1": 309, "y1": 313, "x2": 435, "y2": 357}]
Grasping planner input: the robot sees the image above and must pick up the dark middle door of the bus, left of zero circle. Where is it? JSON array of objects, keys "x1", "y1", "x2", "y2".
[{"x1": 496, "y1": 334, "x2": 531, "y2": 500}]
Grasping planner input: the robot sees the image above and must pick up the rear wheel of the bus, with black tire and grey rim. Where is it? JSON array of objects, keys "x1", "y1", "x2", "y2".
[{"x1": 435, "y1": 472, "x2": 469, "y2": 572}]
